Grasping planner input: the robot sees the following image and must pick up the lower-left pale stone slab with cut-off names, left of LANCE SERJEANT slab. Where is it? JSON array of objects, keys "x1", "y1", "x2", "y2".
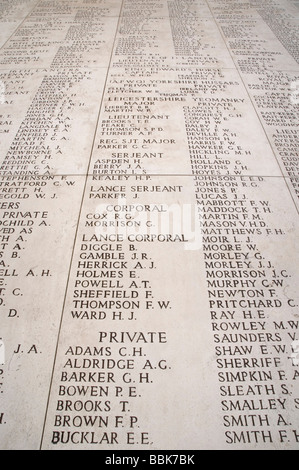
[{"x1": 0, "y1": 175, "x2": 88, "y2": 448}]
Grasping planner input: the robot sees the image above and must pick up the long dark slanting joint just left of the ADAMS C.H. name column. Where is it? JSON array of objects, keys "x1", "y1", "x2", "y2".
[{"x1": 39, "y1": 0, "x2": 124, "y2": 450}]
